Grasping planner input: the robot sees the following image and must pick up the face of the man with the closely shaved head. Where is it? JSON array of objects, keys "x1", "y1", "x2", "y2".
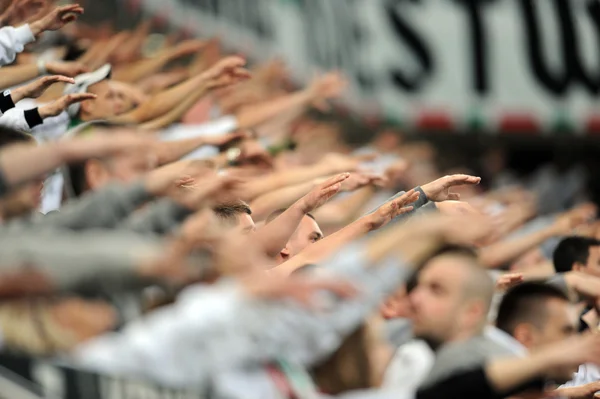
[{"x1": 409, "y1": 256, "x2": 474, "y2": 348}]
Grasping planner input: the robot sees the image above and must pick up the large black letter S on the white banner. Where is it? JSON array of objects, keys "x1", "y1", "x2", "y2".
[{"x1": 385, "y1": 0, "x2": 435, "y2": 92}]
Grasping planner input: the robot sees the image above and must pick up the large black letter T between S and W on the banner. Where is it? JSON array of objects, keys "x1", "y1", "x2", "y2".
[{"x1": 455, "y1": 0, "x2": 495, "y2": 96}]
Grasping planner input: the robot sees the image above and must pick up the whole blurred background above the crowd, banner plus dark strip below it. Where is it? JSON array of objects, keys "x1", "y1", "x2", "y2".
[{"x1": 85, "y1": 0, "x2": 600, "y2": 202}]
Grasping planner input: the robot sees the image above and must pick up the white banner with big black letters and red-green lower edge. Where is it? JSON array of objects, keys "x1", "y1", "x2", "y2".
[{"x1": 135, "y1": 0, "x2": 600, "y2": 132}]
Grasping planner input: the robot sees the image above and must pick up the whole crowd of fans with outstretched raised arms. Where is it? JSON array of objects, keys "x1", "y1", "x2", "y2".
[{"x1": 0, "y1": 0, "x2": 600, "y2": 399}]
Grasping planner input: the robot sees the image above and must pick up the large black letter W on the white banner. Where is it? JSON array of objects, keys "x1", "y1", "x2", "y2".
[{"x1": 518, "y1": 0, "x2": 600, "y2": 97}]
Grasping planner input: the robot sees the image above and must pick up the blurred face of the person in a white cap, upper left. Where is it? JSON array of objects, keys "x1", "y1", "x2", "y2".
[{"x1": 81, "y1": 80, "x2": 125, "y2": 122}]
